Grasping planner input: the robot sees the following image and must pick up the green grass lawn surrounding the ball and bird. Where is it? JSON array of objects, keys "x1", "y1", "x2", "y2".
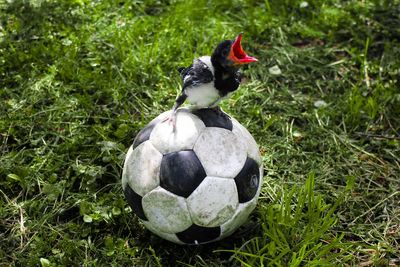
[{"x1": 0, "y1": 0, "x2": 400, "y2": 266}]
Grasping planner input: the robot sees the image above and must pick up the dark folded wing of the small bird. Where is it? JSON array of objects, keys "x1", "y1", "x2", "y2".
[{"x1": 179, "y1": 59, "x2": 214, "y2": 91}]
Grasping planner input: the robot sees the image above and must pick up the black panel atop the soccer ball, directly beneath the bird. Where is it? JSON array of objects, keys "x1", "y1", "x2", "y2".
[{"x1": 193, "y1": 107, "x2": 233, "y2": 131}]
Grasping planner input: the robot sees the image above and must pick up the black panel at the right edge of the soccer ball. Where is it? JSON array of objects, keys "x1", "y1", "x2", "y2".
[{"x1": 235, "y1": 157, "x2": 260, "y2": 203}]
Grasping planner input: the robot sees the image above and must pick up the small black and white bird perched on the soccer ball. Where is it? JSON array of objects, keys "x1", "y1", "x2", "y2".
[{"x1": 165, "y1": 33, "x2": 258, "y2": 128}]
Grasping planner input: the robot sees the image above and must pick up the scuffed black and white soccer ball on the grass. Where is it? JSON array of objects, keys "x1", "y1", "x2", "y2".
[{"x1": 122, "y1": 109, "x2": 263, "y2": 244}]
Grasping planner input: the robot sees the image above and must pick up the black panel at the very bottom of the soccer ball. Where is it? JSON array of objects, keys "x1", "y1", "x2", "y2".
[{"x1": 176, "y1": 224, "x2": 221, "y2": 244}]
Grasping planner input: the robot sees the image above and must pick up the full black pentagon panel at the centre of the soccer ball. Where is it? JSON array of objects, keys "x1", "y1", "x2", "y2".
[{"x1": 160, "y1": 150, "x2": 207, "y2": 197}]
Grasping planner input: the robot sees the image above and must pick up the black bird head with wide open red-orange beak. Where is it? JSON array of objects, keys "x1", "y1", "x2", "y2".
[{"x1": 211, "y1": 33, "x2": 258, "y2": 68}]
